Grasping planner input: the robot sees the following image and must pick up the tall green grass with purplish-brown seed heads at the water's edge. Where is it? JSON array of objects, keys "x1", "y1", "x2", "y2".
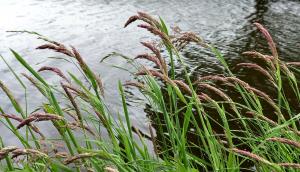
[{"x1": 0, "y1": 12, "x2": 300, "y2": 172}]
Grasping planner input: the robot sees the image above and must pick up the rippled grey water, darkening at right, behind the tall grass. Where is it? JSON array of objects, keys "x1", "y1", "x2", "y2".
[{"x1": 0, "y1": 0, "x2": 300, "y2": 146}]
